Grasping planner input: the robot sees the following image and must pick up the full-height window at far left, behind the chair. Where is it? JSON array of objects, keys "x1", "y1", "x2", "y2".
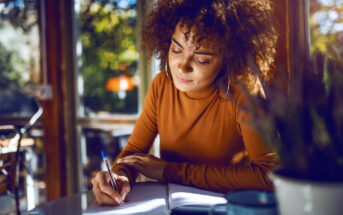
[{"x1": 0, "y1": 0, "x2": 46, "y2": 213}]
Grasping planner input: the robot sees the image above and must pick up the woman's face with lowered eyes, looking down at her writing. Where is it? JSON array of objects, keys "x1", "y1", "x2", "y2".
[{"x1": 168, "y1": 25, "x2": 223, "y2": 92}]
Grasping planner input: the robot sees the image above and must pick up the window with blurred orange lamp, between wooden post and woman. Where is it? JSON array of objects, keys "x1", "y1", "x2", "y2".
[{"x1": 75, "y1": 0, "x2": 142, "y2": 190}]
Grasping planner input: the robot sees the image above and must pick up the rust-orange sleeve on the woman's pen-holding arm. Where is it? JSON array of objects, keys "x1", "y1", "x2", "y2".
[{"x1": 112, "y1": 73, "x2": 159, "y2": 185}]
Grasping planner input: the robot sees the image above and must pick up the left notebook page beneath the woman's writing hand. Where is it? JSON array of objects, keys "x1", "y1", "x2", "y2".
[{"x1": 82, "y1": 182, "x2": 168, "y2": 215}]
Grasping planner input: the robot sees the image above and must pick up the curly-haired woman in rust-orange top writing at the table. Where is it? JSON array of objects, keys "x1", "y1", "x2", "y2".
[{"x1": 92, "y1": 0, "x2": 277, "y2": 205}]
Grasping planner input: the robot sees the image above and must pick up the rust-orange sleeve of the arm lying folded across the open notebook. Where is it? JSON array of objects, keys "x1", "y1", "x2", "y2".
[{"x1": 164, "y1": 91, "x2": 276, "y2": 192}]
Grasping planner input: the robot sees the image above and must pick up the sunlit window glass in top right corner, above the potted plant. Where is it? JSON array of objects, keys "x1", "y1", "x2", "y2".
[{"x1": 310, "y1": 0, "x2": 343, "y2": 56}]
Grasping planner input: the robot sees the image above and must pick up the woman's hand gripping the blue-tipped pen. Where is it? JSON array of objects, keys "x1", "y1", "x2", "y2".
[{"x1": 92, "y1": 171, "x2": 131, "y2": 205}]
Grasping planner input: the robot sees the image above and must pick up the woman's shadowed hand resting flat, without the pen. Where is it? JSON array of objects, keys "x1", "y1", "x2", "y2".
[{"x1": 117, "y1": 154, "x2": 168, "y2": 181}]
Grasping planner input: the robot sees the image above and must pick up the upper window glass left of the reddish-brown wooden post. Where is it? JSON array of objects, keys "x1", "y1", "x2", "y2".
[{"x1": 0, "y1": 0, "x2": 41, "y2": 116}]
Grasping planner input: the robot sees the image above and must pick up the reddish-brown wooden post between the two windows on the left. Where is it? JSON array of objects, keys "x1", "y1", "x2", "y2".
[{"x1": 40, "y1": 0, "x2": 67, "y2": 201}]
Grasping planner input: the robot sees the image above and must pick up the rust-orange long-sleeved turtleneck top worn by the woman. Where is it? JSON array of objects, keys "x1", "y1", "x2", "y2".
[{"x1": 112, "y1": 72, "x2": 273, "y2": 192}]
